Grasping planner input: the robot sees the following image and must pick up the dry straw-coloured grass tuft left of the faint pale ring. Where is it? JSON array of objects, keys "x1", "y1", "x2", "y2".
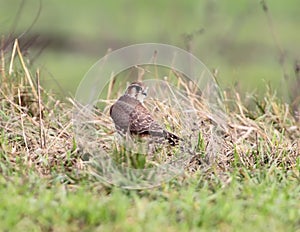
[{"x1": 0, "y1": 40, "x2": 83, "y2": 176}]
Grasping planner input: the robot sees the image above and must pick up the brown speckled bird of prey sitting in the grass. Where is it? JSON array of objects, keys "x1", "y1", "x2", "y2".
[{"x1": 110, "y1": 82, "x2": 181, "y2": 146}]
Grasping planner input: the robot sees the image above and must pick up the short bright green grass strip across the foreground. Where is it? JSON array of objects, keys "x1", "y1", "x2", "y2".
[{"x1": 0, "y1": 169, "x2": 300, "y2": 231}]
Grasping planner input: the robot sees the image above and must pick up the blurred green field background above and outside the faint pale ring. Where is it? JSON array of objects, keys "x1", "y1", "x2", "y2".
[{"x1": 0, "y1": 0, "x2": 300, "y2": 96}]
